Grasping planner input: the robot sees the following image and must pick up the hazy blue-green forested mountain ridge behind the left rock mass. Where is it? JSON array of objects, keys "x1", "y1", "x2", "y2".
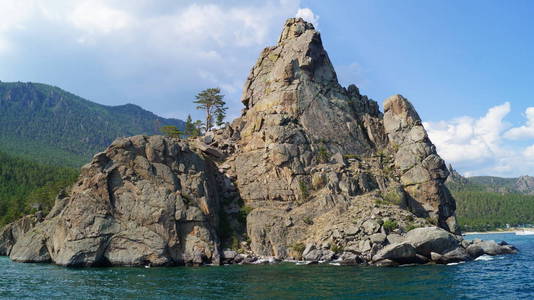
[{"x1": 0, "y1": 82, "x2": 184, "y2": 167}]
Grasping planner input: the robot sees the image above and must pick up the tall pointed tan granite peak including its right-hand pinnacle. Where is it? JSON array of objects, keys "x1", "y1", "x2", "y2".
[{"x1": 229, "y1": 19, "x2": 457, "y2": 257}]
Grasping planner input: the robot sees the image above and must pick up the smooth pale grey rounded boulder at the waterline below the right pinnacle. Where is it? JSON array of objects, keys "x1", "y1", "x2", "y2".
[{"x1": 405, "y1": 227, "x2": 459, "y2": 257}]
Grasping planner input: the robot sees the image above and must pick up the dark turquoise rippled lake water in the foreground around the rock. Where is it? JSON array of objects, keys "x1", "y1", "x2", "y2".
[{"x1": 0, "y1": 234, "x2": 534, "y2": 299}]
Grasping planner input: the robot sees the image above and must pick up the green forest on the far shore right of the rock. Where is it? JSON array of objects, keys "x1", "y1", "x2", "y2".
[{"x1": 449, "y1": 183, "x2": 534, "y2": 231}]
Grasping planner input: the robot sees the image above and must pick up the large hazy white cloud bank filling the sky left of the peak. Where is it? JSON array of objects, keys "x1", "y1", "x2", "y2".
[{"x1": 0, "y1": 0, "x2": 304, "y2": 120}]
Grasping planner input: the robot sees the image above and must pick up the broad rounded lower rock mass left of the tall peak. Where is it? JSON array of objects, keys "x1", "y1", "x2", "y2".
[{"x1": 10, "y1": 136, "x2": 223, "y2": 266}]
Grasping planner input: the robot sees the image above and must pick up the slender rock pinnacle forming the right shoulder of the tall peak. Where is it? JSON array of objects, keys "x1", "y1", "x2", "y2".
[{"x1": 384, "y1": 95, "x2": 458, "y2": 232}]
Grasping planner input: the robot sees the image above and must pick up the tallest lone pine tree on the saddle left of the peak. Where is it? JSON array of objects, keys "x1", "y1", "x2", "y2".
[{"x1": 193, "y1": 88, "x2": 227, "y2": 131}]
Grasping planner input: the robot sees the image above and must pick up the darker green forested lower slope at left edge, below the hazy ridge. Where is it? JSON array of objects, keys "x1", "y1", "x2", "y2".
[{"x1": 0, "y1": 152, "x2": 78, "y2": 228}]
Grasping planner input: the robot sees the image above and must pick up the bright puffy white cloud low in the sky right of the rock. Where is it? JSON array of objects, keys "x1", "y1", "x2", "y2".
[{"x1": 430, "y1": 102, "x2": 534, "y2": 177}]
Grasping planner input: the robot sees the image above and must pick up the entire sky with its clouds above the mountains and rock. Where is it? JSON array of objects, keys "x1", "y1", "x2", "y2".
[{"x1": 0, "y1": 0, "x2": 534, "y2": 176}]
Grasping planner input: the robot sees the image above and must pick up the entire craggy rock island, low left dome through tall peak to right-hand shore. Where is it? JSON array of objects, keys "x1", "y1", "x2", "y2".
[{"x1": 0, "y1": 19, "x2": 517, "y2": 266}]
